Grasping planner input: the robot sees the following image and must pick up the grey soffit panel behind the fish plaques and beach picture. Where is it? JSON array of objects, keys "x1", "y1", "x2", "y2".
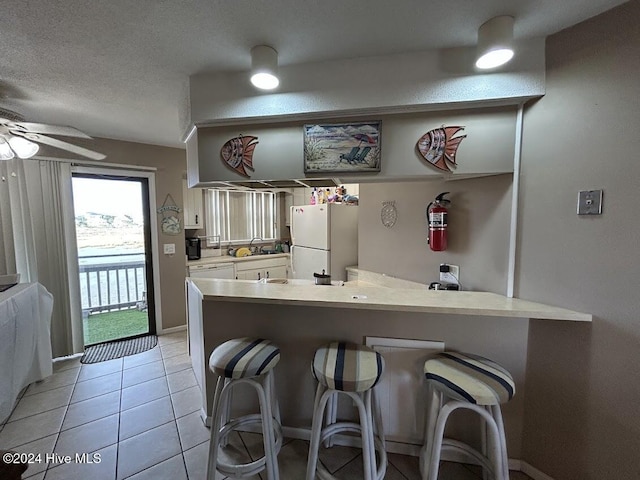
[{"x1": 187, "y1": 106, "x2": 517, "y2": 186}]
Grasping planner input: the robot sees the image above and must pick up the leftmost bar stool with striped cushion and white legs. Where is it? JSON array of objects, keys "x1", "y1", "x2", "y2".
[{"x1": 207, "y1": 337, "x2": 282, "y2": 480}]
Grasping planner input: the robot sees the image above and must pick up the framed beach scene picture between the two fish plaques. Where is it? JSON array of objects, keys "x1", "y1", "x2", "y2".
[{"x1": 304, "y1": 121, "x2": 381, "y2": 173}]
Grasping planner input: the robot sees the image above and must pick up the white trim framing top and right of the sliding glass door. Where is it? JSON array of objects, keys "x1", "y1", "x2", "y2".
[{"x1": 71, "y1": 165, "x2": 163, "y2": 333}]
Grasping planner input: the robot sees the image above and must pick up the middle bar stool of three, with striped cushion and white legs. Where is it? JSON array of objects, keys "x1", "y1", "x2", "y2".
[{"x1": 307, "y1": 342, "x2": 387, "y2": 480}]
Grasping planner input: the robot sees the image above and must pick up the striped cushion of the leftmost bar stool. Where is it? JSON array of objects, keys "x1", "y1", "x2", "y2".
[{"x1": 209, "y1": 337, "x2": 280, "y2": 379}]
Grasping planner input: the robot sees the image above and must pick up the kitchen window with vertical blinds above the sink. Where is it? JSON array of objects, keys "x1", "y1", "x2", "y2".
[{"x1": 205, "y1": 189, "x2": 276, "y2": 242}]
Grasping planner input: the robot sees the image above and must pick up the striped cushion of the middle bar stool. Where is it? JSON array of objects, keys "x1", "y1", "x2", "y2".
[{"x1": 311, "y1": 342, "x2": 384, "y2": 392}]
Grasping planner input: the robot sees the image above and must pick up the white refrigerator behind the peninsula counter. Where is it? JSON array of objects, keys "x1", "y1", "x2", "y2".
[{"x1": 291, "y1": 203, "x2": 358, "y2": 280}]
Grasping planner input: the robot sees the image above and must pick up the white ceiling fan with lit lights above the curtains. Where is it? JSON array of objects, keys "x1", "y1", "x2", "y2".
[{"x1": 0, "y1": 108, "x2": 106, "y2": 160}]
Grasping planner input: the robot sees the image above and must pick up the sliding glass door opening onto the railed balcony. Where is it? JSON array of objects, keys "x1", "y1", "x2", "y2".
[{"x1": 72, "y1": 172, "x2": 156, "y2": 346}]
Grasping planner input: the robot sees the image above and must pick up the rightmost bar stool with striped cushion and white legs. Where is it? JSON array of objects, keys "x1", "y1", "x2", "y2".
[{"x1": 420, "y1": 352, "x2": 515, "y2": 480}]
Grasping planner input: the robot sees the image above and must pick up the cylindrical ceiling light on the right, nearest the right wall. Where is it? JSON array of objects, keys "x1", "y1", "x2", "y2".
[{"x1": 476, "y1": 15, "x2": 513, "y2": 70}]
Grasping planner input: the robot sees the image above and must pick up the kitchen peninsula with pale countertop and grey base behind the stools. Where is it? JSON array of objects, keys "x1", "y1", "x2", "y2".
[{"x1": 187, "y1": 276, "x2": 591, "y2": 458}]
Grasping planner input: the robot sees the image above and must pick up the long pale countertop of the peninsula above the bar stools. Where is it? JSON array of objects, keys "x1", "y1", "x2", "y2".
[{"x1": 188, "y1": 279, "x2": 592, "y2": 322}]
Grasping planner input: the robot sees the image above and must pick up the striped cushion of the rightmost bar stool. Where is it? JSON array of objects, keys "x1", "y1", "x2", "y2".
[{"x1": 424, "y1": 352, "x2": 516, "y2": 405}]
